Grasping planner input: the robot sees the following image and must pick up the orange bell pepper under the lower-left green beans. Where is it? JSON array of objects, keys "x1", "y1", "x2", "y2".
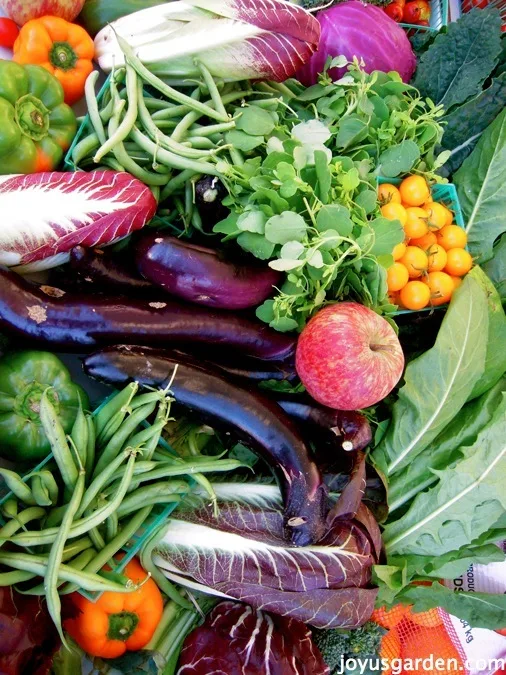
[{"x1": 63, "y1": 558, "x2": 163, "y2": 659}]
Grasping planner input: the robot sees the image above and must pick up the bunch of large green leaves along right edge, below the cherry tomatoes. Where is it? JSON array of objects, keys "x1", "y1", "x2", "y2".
[{"x1": 372, "y1": 267, "x2": 506, "y2": 628}]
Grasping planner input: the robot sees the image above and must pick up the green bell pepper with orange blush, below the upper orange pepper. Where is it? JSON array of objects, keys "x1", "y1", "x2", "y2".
[{"x1": 0, "y1": 59, "x2": 77, "y2": 174}]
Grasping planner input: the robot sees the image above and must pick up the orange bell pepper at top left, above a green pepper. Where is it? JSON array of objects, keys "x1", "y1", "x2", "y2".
[{"x1": 13, "y1": 16, "x2": 95, "y2": 105}]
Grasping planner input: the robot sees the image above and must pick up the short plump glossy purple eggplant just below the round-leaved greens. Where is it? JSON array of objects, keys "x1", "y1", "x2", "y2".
[{"x1": 135, "y1": 232, "x2": 281, "y2": 310}]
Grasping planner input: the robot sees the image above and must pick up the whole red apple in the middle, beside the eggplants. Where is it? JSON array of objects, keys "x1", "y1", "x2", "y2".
[{"x1": 296, "y1": 302, "x2": 404, "y2": 410}]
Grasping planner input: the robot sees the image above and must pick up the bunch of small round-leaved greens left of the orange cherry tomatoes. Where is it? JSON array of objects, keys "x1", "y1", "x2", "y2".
[{"x1": 214, "y1": 57, "x2": 446, "y2": 331}]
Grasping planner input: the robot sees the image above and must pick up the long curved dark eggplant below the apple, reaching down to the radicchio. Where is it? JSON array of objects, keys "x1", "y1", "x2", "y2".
[{"x1": 83, "y1": 345, "x2": 328, "y2": 546}]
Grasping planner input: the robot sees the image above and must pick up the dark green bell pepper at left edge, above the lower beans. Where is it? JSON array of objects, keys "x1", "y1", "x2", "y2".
[{"x1": 0, "y1": 351, "x2": 89, "y2": 464}]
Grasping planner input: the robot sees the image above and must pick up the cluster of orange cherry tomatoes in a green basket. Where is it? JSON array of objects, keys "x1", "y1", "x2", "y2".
[{"x1": 378, "y1": 176, "x2": 473, "y2": 310}]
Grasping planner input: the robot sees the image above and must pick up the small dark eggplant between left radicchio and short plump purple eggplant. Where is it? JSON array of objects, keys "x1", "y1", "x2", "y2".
[{"x1": 69, "y1": 246, "x2": 155, "y2": 296}]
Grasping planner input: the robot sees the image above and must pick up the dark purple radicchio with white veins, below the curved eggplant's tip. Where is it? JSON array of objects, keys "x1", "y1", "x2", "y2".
[{"x1": 154, "y1": 502, "x2": 376, "y2": 628}]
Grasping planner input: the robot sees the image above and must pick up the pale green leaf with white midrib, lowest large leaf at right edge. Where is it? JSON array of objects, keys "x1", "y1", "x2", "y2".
[{"x1": 383, "y1": 396, "x2": 506, "y2": 556}]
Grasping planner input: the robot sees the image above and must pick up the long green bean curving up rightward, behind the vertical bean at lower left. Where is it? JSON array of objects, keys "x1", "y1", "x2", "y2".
[{"x1": 7, "y1": 450, "x2": 136, "y2": 548}]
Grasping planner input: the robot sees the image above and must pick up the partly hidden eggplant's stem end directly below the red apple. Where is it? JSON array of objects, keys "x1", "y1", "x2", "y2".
[{"x1": 277, "y1": 399, "x2": 372, "y2": 451}]
